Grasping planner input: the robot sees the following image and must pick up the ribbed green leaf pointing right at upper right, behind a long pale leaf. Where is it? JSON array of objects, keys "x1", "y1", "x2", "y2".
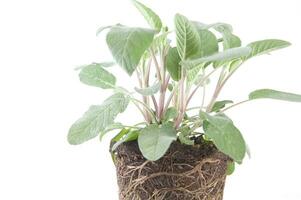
[{"x1": 246, "y1": 39, "x2": 291, "y2": 59}]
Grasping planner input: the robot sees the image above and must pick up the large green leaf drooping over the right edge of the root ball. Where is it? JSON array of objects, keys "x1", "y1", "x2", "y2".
[{"x1": 201, "y1": 112, "x2": 246, "y2": 163}]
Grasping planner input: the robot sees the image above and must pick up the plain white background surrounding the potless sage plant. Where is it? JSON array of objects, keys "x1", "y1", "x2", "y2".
[{"x1": 0, "y1": 0, "x2": 301, "y2": 200}]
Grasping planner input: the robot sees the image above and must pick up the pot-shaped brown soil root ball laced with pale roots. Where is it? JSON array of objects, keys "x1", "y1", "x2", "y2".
[{"x1": 116, "y1": 140, "x2": 230, "y2": 200}]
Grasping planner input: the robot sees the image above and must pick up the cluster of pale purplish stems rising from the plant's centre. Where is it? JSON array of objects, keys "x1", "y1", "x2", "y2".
[{"x1": 132, "y1": 45, "x2": 246, "y2": 129}]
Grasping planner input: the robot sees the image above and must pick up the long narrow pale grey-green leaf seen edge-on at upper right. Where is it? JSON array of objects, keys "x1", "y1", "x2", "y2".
[{"x1": 182, "y1": 47, "x2": 252, "y2": 68}]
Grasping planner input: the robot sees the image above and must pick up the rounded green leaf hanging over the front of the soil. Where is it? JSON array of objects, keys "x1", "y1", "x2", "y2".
[{"x1": 138, "y1": 124, "x2": 177, "y2": 161}]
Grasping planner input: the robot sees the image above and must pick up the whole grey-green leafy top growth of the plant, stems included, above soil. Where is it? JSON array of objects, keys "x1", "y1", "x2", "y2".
[{"x1": 68, "y1": 0, "x2": 301, "y2": 167}]
